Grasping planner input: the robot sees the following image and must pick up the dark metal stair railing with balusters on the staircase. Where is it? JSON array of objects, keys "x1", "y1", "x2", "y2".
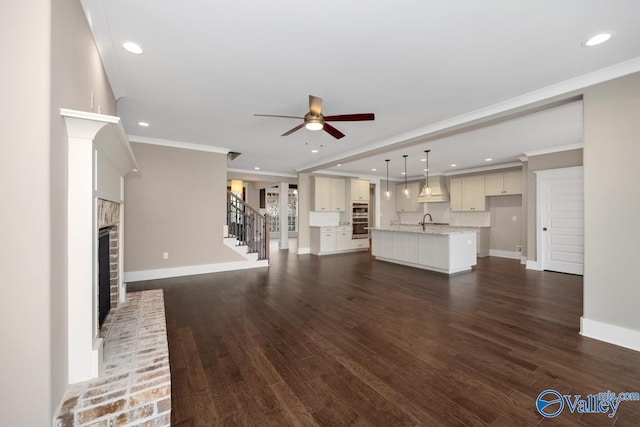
[{"x1": 227, "y1": 191, "x2": 269, "y2": 260}]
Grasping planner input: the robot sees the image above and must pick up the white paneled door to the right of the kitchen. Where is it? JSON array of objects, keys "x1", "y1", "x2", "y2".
[{"x1": 538, "y1": 167, "x2": 584, "y2": 275}]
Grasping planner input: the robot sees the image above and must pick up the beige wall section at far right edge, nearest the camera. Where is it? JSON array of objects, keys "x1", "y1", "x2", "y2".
[{"x1": 584, "y1": 73, "x2": 640, "y2": 334}]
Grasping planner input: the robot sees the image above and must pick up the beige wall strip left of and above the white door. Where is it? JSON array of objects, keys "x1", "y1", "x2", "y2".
[{"x1": 526, "y1": 149, "x2": 582, "y2": 261}]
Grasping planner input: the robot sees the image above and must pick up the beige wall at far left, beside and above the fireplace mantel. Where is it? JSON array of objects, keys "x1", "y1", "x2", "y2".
[{"x1": 0, "y1": 0, "x2": 115, "y2": 426}]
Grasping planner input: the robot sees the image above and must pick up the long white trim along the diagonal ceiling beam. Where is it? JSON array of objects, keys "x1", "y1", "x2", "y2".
[{"x1": 297, "y1": 56, "x2": 640, "y2": 172}]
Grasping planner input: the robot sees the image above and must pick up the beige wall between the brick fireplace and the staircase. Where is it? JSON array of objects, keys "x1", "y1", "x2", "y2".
[{"x1": 124, "y1": 143, "x2": 242, "y2": 272}]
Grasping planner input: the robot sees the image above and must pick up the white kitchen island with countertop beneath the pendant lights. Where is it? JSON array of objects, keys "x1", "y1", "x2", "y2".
[{"x1": 370, "y1": 225, "x2": 478, "y2": 274}]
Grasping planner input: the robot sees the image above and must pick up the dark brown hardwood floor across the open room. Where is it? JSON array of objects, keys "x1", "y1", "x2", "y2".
[{"x1": 129, "y1": 246, "x2": 640, "y2": 427}]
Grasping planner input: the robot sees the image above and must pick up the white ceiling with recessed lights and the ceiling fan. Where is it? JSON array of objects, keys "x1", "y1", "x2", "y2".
[{"x1": 82, "y1": 0, "x2": 640, "y2": 179}]
